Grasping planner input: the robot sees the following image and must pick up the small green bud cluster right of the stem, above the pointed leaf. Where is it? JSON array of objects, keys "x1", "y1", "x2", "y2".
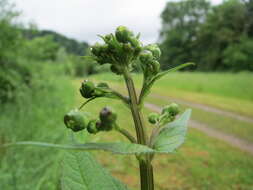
[{"x1": 148, "y1": 103, "x2": 179, "y2": 125}]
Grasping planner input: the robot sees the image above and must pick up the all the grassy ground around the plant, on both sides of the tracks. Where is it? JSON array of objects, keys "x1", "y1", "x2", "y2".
[{"x1": 0, "y1": 73, "x2": 253, "y2": 190}]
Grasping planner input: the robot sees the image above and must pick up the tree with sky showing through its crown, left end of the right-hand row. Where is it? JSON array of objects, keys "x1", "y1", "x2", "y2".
[{"x1": 160, "y1": 0, "x2": 210, "y2": 69}]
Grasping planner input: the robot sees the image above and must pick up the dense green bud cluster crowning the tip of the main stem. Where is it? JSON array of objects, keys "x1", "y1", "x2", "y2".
[{"x1": 91, "y1": 26, "x2": 142, "y2": 74}]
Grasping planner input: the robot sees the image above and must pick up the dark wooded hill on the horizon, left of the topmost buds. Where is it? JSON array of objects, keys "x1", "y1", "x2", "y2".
[{"x1": 23, "y1": 29, "x2": 89, "y2": 56}]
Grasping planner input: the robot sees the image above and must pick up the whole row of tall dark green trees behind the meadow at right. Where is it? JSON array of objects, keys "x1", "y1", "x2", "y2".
[{"x1": 159, "y1": 0, "x2": 253, "y2": 71}]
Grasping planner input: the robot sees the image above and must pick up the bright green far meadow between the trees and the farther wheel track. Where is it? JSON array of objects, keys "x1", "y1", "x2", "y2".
[{"x1": 90, "y1": 72, "x2": 253, "y2": 117}]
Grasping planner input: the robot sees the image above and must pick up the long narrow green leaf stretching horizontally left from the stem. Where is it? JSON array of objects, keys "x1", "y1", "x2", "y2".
[{"x1": 3, "y1": 141, "x2": 154, "y2": 154}]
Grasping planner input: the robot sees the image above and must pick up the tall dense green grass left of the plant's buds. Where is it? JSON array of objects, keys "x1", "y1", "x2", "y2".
[{"x1": 0, "y1": 77, "x2": 76, "y2": 190}]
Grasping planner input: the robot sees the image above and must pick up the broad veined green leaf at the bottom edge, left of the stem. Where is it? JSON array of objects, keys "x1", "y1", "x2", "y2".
[{"x1": 61, "y1": 152, "x2": 127, "y2": 190}]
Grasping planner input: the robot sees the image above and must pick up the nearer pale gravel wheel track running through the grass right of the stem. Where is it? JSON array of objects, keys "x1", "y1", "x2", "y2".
[{"x1": 145, "y1": 103, "x2": 253, "y2": 155}]
